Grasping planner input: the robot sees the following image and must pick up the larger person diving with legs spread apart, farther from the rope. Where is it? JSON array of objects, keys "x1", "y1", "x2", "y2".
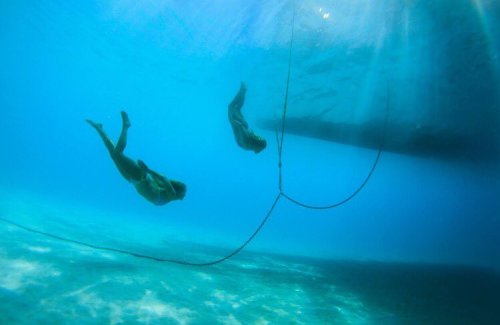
[{"x1": 86, "y1": 111, "x2": 186, "y2": 205}]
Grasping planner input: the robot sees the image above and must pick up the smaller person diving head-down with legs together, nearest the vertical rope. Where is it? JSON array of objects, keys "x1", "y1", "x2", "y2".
[{"x1": 228, "y1": 82, "x2": 267, "y2": 153}]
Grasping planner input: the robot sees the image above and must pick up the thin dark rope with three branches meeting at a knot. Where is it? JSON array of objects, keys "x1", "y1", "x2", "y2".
[{"x1": 0, "y1": 6, "x2": 388, "y2": 266}]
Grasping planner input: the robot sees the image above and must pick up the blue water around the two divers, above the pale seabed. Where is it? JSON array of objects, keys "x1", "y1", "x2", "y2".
[{"x1": 0, "y1": 0, "x2": 500, "y2": 268}]
